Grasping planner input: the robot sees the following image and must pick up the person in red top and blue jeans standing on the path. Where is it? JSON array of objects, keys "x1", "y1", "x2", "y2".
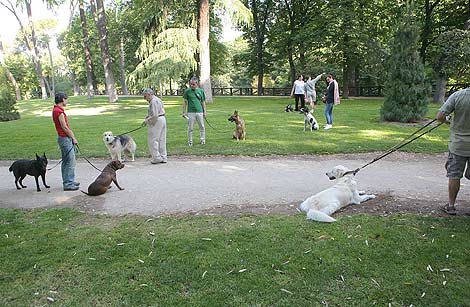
[{"x1": 52, "y1": 93, "x2": 80, "y2": 191}]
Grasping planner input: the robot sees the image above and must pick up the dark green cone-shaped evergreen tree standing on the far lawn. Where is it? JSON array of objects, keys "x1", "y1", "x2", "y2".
[{"x1": 380, "y1": 1, "x2": 428, "y2": 122}]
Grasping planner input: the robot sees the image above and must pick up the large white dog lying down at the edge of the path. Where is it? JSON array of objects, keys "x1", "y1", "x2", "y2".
[{"x1": 300, "y1": 165, "x2": 375, "y2": 222}]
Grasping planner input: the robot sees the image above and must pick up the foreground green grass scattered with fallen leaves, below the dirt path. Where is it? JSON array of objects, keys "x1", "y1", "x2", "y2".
[{"x1": 0, "y1": 209, "x2": 470, "y2": 306}]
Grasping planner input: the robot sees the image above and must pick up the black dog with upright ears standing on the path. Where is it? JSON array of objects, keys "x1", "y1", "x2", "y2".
[{"x1": 9, "y1": 153, "x2": 50, "y2": 192}]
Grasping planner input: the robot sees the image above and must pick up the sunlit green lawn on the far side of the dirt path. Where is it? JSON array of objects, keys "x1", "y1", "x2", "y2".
[{"x1": 0, "y1": 97, "x2": 448, "y2": 160}]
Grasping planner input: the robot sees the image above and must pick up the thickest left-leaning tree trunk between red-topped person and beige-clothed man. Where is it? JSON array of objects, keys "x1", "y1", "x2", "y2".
[{"x1": 92, "y1": 0, "x2": 118, "y2": 102}]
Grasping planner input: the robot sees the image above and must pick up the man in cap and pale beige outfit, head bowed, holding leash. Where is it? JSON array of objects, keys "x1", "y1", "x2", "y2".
[{"x1": 142, "y1": 88, "x2": 168, "y2": 164}]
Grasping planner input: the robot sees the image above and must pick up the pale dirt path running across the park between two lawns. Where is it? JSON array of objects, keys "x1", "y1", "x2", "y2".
[{"x1": 0, "y1": 153, "x2": 470, "y2": 216}]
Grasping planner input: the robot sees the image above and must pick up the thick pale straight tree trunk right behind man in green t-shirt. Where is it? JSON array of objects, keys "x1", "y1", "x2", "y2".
[{"x1": 197, "y1": 0, "x2": 212, "y2": 102}]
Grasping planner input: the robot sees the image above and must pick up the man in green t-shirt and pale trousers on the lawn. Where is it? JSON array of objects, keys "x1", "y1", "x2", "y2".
[{"x1": 182, "y1": 77, "x2": 206, "y2": 146}]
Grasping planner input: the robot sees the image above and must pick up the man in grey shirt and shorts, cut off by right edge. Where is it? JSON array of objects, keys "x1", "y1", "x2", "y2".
[{"x1": 436, "y1": 87, "x2": 470, "y2": 215}]
